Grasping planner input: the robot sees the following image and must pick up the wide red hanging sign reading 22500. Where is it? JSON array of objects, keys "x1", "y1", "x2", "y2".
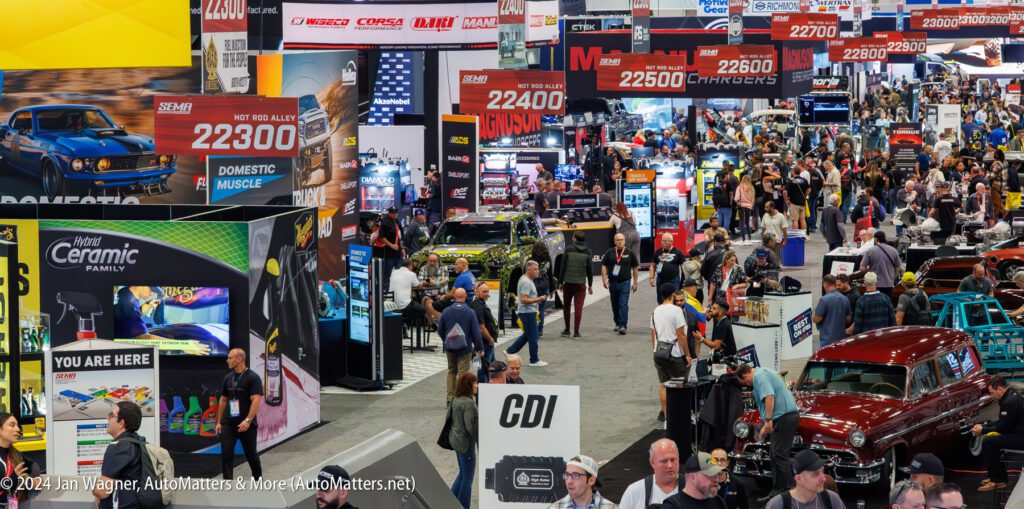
[{"x1": 595, "y1": 51, "x2": 686, "y2": 92}]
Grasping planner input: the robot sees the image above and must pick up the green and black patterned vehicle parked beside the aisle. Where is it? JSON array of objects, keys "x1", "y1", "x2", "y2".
[{"x1": 413, "y1": 212, "x2": 565, "y2": 309}]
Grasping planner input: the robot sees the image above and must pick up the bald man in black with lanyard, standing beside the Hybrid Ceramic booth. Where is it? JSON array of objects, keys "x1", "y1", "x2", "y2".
[{"x1": 216, "y1": 348, "x2": 263, "y2": 479}]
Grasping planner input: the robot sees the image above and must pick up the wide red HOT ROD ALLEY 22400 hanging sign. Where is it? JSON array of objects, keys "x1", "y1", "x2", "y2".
[{"x1": 459, "y1": 71, "x2": 565, "y2": 115}]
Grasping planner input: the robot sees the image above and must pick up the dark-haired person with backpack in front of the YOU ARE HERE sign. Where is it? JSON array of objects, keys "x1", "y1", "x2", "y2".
[{"x1": 92, "y1": 401, "x2": 145, "y2": 509}]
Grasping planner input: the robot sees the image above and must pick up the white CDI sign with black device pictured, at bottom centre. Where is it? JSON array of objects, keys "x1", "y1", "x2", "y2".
[{"x1": 476, "y1": 384, "x2": 580, "y2": 509}]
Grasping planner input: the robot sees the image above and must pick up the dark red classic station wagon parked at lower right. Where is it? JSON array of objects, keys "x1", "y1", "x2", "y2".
[{"x1": 730, "y1": 327, "x2": 996, "y2": 489}]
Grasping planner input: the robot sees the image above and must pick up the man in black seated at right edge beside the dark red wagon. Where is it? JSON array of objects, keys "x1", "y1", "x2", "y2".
[{"x1": 971, "y1": 376, "x2": 1024, "y2": 492}]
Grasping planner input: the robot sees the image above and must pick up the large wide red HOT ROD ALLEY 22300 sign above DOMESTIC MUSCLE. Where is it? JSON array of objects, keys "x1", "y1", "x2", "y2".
[{"x1": 153, "y1": 95, "x2": 299, "y2": 158}]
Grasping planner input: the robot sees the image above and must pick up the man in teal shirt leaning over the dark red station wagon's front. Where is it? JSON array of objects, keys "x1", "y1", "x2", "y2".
[{"x1": 736, "y1": 365, "x2": 800, "y2": 502}]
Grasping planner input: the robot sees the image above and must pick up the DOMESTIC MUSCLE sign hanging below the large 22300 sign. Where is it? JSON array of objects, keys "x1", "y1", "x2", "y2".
[{"x1": 207, "y1": 157, "x2": 294, "y2": 205}]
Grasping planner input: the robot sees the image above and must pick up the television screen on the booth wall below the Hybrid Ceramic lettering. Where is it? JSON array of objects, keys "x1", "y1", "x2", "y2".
[{"x1": 114, "y1": 286, "x2": 230, "y2": 356}]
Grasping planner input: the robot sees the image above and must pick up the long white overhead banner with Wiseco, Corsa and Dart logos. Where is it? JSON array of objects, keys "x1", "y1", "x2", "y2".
[{"x1": 283, "y1": 0, "x2": 558, "y2": 49}]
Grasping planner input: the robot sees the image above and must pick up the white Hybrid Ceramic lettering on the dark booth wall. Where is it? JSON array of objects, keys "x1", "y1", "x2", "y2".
[{"x1": 46, "y1": 236, "x2": 138, "y2": 272}]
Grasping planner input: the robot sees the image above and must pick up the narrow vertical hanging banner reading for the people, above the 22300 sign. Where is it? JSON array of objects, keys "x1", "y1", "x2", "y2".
[{"x1": 201, "y1": 0, "x2": 249, "y2": 93}]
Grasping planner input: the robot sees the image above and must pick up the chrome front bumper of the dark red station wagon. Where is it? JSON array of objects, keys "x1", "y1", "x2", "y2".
[{"x1": 729, "y1": 443, "x2": 886, "y2": 484}]
